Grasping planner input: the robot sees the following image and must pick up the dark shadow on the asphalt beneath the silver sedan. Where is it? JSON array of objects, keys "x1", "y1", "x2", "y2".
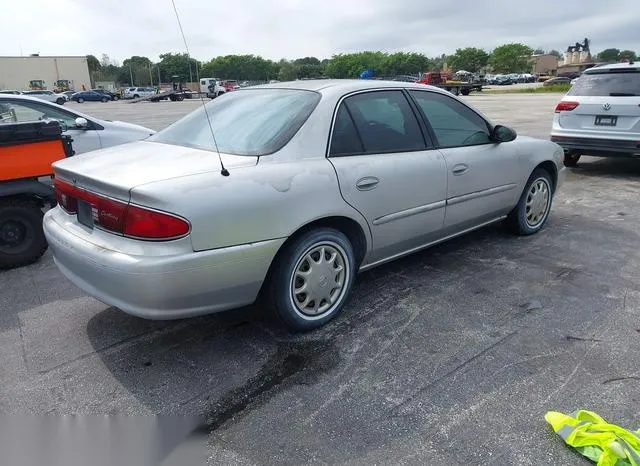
[{"x1": 87, "y1": 222, "x2": 510, "y2": 418}]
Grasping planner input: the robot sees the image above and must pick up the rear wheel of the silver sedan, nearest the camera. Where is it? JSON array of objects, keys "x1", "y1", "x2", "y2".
[{"x1": 267, "y1": 228, "x2": 357, "y2": 332}]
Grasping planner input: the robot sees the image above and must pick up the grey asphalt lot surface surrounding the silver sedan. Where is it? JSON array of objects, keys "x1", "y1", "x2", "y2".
[{"x1": 0, "y1": 94, "x2": 640, "y2": 465}]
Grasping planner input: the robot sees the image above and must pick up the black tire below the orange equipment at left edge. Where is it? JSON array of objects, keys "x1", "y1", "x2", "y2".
[{"x1": 0, "y1": 199, "x2": 47, "y2": 269}]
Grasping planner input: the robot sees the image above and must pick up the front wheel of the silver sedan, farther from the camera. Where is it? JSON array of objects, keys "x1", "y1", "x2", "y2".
[{"x1": 507, "y1": 168, "x2": 553, "y2": 236}]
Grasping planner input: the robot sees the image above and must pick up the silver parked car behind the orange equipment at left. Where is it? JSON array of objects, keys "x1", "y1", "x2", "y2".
[{"x1": 0, "y1": 95, "x2": 155, "y2": 154}]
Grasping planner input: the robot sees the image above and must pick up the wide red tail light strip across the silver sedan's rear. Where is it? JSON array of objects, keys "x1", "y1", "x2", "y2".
[{"x1": 54, "y1": 178, "x2": 190, "y2": 240}]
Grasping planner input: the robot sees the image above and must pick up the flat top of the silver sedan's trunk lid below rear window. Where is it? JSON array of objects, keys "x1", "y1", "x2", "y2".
[{"x1": 53, "y1": 141, "x2": 258, "y2": 199}]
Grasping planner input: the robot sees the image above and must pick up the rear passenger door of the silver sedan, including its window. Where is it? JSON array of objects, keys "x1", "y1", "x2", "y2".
[{"x1": 329, "y1": 89, "x2": 446, "y2": 262}]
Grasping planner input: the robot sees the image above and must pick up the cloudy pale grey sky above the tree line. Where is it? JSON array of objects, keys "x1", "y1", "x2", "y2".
[{"x1": 0, "y1": 0, "x2": 640, "y2": 62}]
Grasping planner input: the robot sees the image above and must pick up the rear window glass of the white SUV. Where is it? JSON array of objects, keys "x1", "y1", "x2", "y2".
[{"x1": 567, "y1": 71, "x2": 640, "y2": 97}]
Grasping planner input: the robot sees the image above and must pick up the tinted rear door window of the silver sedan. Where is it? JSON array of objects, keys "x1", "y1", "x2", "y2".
[{"x1": 330, "y1": 90, "x2": 426, "y2": 156}]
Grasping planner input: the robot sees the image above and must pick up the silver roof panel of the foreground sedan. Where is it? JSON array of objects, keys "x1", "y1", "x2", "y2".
[{"x1": 244, "y1": 79, "x2": 445, "y2": 95}]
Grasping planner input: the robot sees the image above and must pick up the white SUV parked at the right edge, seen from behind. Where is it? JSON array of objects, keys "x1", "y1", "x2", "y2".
[{"x1": 551, "y1": 62, "x2": 640, "y2": 167}]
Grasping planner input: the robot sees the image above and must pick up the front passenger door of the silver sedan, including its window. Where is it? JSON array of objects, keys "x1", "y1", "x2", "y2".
[{"x1": 410, "y1": 90, "x2": 520, "y2": 230}]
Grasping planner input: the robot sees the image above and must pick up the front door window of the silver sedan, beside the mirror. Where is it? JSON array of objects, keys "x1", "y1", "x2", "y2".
[{"x1": 410, "y1": 90, "x2": 492, "y2": 147}]
